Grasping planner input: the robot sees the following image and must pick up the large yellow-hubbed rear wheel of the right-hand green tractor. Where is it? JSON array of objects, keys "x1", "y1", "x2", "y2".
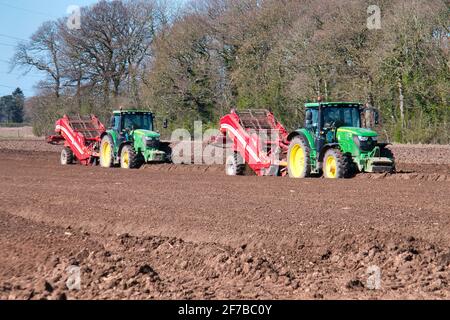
[{"x1": 288, "y1": 137, "x2": 311, "y2": 179}]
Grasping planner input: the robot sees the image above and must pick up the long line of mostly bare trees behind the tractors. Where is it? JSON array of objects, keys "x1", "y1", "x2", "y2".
[{"x1": 14, "y1": 0, "x2": 450, "y2": 143}]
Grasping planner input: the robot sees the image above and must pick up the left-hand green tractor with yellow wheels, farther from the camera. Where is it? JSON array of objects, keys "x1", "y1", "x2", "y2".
[{"x1": 100, "y1": 110, "x2": 171, "y2": 169}]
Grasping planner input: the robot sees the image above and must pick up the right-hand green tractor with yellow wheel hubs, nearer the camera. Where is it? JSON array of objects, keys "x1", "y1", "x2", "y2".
[{"x1": 287, "y1": 102, "x2": 395, "y2": 179}]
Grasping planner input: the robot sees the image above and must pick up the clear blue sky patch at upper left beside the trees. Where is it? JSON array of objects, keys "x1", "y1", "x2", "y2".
[{"x1": 0, "y1": 0, "x2": 97, "y2": 97}]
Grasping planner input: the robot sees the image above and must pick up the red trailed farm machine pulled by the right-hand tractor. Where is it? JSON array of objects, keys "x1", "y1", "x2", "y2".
[{"x1": 220, "y1": 110, "x2": 289, "y2": 176}]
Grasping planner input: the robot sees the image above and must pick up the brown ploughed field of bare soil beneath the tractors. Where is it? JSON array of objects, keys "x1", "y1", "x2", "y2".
[{"x1": 0, "y1": 140, "x2": 450, "y2": 299}]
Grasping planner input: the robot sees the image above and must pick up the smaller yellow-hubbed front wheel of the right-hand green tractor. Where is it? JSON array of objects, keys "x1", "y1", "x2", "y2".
[{"x1": 323, "y1": 149, "x2": 353, "y2": 179}]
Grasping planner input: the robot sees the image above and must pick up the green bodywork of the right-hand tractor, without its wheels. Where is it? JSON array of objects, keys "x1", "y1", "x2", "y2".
[{"x1": 290, "y1": 102, "x2": 395, "y2": 173}]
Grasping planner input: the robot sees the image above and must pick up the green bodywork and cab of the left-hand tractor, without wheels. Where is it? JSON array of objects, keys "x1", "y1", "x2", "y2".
[{"x1": 105, "y1": 110, "x2": 168, "y2": 164}]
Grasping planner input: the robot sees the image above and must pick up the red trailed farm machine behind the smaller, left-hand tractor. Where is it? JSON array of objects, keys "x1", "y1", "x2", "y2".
[{"x1": 47, "y1": 115, "x2": 106, "y2": 165}]
